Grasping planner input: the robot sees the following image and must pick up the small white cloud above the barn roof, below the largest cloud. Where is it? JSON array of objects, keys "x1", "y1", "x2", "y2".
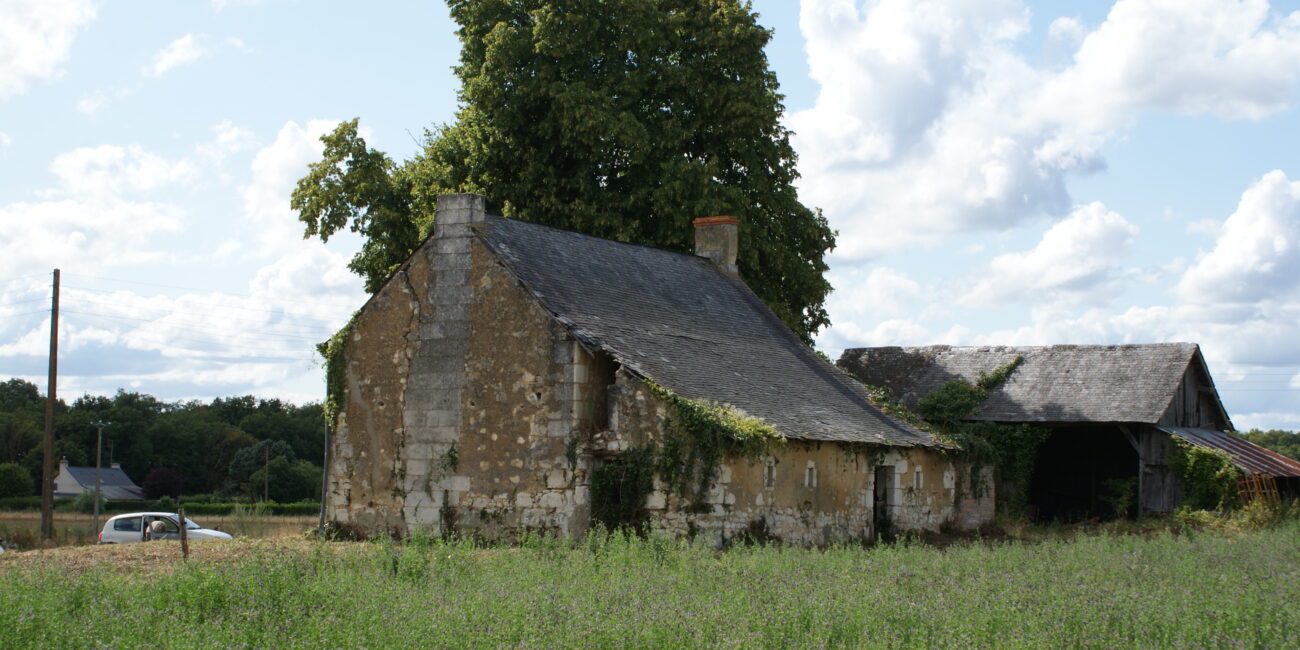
[{"x1": 959, "y1": 203, "x2": 1138, "y2": 307}]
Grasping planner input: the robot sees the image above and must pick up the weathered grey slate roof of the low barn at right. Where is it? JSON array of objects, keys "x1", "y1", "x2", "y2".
[{"x1": 840, "y1": 343, "x2": 1211, "y2": 424}]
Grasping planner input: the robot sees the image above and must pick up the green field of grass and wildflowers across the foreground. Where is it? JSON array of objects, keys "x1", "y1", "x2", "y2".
[{"x1": 0, "y1": 520, "x2": 1300, "y2": 647}]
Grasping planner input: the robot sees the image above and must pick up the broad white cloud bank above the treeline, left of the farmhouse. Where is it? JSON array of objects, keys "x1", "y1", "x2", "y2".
[{"x1": 0, "y1": 122, "x2": 365, "y2": 400}]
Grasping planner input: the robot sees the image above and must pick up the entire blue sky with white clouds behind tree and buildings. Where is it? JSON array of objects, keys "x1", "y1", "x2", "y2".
[{"x1": 0, "y1": 0, "x2": 1300, "y2": 429}]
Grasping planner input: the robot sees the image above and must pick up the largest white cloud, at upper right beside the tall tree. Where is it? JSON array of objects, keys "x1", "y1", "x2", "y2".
[{"x1": 789, "y1": 0, "x2": 1300, "y2": 260}]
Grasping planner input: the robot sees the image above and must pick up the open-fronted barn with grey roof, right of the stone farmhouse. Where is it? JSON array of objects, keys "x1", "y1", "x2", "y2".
[{"x1": 839, "y1": 343, "x2": 1300, "y2": 519}]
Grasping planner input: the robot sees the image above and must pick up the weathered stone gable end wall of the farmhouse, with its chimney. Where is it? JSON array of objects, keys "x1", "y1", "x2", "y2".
[{"x1": 328, "y1": 198, "x2": 605, "y2": 537}]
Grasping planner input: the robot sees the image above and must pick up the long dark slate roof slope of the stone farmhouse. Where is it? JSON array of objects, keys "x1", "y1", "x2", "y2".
[{"x1": 476, "y1": 215, "x2": 939, "y2": 446}]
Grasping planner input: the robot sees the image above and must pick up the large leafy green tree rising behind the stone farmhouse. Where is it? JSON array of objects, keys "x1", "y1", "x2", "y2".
[{"x1": 293, "y1": 0, "x2": 835, "y2": 339}]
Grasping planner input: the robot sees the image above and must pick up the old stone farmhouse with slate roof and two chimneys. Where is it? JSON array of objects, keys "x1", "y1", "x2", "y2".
[{"x1": 326, "y1": 195, "x2": 993, "y2": 545}]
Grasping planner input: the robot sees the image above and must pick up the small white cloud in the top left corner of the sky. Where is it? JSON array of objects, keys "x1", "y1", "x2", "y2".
[{"x1": 0, "y1": 0, "x2": 95, "y2": 99}]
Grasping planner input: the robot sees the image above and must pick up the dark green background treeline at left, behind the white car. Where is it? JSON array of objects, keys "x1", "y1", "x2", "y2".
[{"x1": 0, "y1": 380, "x2": 325, "y2": 503}]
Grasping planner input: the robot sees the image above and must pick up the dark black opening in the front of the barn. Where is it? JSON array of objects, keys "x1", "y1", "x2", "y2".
[{"x1": 1030, "y1": 426, "x2": 1138, "y2": 521}]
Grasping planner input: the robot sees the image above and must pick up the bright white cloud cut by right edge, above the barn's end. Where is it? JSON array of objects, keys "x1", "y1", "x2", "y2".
[{"x1": 1178, "y1": 170, "x2": 1300, "y2": 304}]
